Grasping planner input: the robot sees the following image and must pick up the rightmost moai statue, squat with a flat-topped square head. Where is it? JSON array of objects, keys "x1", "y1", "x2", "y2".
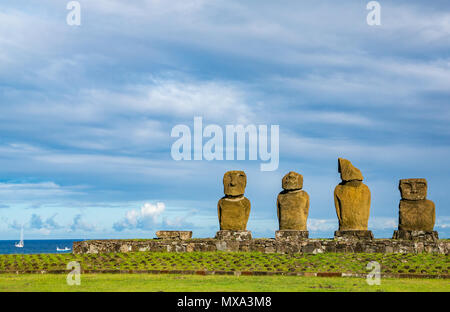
[{"x1": 393, "y1": 179, "x2": 438, "y2": 240}]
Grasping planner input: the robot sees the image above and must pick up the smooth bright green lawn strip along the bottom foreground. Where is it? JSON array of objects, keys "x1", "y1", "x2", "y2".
[{"x1": 0, "y1": 274, "x2": 450, "y2": 292}]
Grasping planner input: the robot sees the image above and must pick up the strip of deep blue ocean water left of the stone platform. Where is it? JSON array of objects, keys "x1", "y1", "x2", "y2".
[{"x1": 0, "y1": 239, "x2": 82, "y2": 254}]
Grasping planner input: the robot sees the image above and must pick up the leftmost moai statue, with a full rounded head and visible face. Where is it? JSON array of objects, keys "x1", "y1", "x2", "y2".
[{"x1": 216, "y1": 171, "x2": 251, "y2": 239}]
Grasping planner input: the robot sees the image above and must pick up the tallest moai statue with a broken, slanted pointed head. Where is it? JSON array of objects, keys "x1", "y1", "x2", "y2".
[{"x1": 334, "y1": 158, "x2": 373, "y2": 239}]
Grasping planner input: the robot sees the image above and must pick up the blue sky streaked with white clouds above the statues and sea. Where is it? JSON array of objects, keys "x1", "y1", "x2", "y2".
[{"x1": 0, "y1": 0, "x2": 450, "y2": 239}]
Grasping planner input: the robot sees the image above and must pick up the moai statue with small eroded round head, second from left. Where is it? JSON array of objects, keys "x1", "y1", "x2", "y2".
[{"x1": 275, "y1": 171, "x2": 309, "y2": 240}]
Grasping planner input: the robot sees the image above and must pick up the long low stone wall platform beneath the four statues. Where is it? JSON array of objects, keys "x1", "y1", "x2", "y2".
[{"x1": 73, "y1": 238, "x2": 450, "y2": 254}]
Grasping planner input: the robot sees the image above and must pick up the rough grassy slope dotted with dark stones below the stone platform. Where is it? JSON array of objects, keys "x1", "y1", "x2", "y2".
[{"x1": 0, "y1": 252, "x2": 450, "y2": 275}]
